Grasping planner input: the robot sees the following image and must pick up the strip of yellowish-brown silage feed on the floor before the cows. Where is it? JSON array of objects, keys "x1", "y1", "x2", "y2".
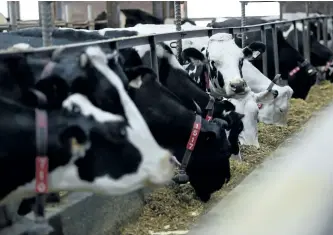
[{"x1": 121, "y1": 81, "x2": 333, "y2": 235}]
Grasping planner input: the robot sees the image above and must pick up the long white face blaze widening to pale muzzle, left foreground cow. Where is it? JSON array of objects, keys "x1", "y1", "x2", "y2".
[{"x1": 85, "y1": 47, "x2": 174, "y2": 187}]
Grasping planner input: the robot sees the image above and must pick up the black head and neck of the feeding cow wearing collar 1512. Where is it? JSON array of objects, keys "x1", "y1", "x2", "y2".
[{"x1": 127, "y1": 63, "x2": 230, "y2": 201}]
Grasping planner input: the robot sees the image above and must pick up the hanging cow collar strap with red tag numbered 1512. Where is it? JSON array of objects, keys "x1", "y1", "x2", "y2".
[{"x1": 173, "y1": 114, "x2": 202, "y2": 184}]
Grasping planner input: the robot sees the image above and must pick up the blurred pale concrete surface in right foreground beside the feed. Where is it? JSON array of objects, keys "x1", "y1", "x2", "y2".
[{"x1": 187, "y1": 105, "x2": 333, "y2": 235}]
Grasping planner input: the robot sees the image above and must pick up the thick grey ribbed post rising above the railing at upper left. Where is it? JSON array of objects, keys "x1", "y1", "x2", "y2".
[{"x1": 41, "y1": 1, "x2": 53, "y2": 47}]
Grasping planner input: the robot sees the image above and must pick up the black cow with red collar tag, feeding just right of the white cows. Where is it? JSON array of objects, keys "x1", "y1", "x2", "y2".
[{"x1": 212, "y1": 18, "x2": 318, "y2": 99}]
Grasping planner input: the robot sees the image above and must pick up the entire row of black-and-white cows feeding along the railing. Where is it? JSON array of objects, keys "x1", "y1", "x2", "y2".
[{"x1": 0, "y1": 8, "x2": 333, "y2": 233}]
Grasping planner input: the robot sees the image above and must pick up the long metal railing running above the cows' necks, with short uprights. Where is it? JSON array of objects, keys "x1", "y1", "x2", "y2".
[{"x1": 0, "y1": 16, "x2": 333, "y2": 80}]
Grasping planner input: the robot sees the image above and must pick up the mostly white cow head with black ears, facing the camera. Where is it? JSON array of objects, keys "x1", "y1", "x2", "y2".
[{"x1": 183, "y1": 33, "x2": 265, "y2": 97}]
